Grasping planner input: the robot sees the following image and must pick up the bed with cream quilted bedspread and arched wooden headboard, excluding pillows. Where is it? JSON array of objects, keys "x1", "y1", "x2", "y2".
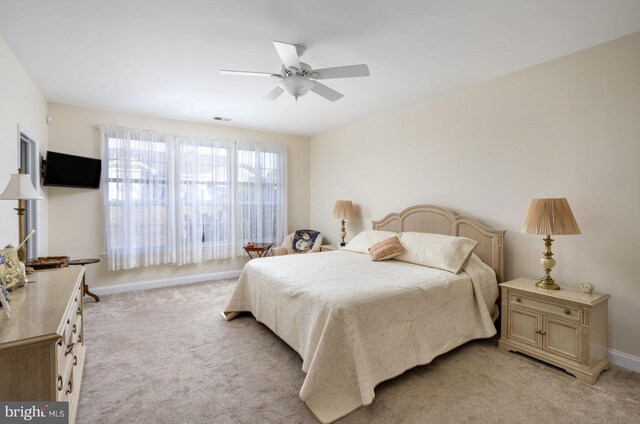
[{"x1": 223, "y1": 205, "x2": 505, "y2": 423}]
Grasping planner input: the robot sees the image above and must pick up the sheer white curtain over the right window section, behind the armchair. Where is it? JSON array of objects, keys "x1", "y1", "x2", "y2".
[{"x1": 236, "y1": 142, "x2": 287, "y2": 255}]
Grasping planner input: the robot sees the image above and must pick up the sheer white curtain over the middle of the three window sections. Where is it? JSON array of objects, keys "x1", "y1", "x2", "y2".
[{"x1": 175, "y1": 137, "x2": 234, "y2": 265}]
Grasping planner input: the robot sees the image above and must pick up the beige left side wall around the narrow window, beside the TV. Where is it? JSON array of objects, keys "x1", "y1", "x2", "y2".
[{"x1": 0, "y1": 37, "x2": 48, "y2": 254}]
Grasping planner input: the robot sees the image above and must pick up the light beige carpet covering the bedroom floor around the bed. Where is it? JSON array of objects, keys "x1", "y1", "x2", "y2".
[{"x1": 77, "y1": 281, "x2": 640, "y2": 424}]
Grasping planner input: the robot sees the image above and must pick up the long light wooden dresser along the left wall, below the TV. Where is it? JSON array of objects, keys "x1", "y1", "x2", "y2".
[{"x1": 0, "y1": 267, "x2": 85, "y2": 423}]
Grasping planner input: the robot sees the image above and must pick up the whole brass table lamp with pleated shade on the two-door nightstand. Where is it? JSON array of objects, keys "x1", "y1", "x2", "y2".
[{"x1": 522, "y1": 198, "x2": 580, "y2": 290}]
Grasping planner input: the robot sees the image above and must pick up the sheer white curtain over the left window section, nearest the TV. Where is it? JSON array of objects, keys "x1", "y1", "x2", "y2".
[{"x1": 100, "y1": 127, "x2": 173, "y2": 270}]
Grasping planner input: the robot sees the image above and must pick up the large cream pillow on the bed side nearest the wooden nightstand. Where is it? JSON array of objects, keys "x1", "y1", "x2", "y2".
[{"x1": 394, "y1": 231, "x2": 478, "y2": 274}]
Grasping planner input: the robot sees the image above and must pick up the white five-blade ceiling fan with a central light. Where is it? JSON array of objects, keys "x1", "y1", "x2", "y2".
[{"x1": 220, "y1": 41, "x2": 369, "y2": 102}]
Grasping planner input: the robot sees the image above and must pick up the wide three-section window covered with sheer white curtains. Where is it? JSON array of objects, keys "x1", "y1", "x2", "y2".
[{"x1": 101, "y1": 128, "x2": 286, "y2": 270}]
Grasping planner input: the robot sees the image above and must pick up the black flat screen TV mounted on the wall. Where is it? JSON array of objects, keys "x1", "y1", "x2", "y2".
[{"x1": 44, "y1": 152, "x2": 102, "y2": 188}]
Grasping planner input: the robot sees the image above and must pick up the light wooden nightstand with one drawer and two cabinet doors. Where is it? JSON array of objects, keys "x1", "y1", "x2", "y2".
[{"x1": 498, "y1": 278, "x2": 610, "y2": 384}]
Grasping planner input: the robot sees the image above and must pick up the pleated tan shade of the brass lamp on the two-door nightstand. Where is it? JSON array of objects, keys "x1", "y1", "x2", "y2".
[{"x1": 521, "y1": 197, "x2": 580, "y2": 235}]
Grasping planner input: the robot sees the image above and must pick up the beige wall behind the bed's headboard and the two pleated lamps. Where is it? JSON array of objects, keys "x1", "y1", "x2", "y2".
[{"x1": 311, "y1": 33, "x2": 640, "y2": 356}]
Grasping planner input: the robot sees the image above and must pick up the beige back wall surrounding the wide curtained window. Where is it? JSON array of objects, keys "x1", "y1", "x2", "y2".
[{"x1": 48, "y1": 103, "x2": 309, "y2": 287}]
